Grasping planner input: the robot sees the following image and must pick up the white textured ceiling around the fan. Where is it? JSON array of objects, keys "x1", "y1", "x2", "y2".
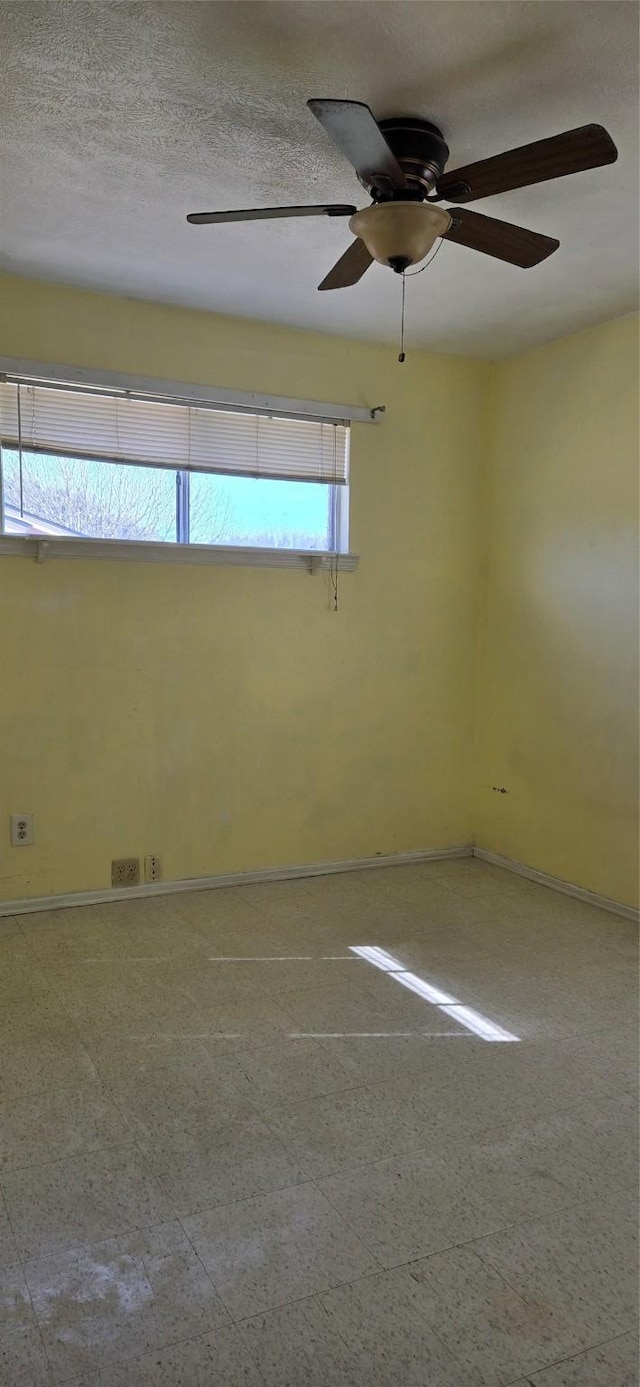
[{"x1": 0, "y1": 0, "x2": 639, "y2": 358}]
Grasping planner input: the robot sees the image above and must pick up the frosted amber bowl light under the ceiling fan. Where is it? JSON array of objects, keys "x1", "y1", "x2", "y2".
[{"x1": 348, "y1": 201, "x2": 451, "y2": 273}]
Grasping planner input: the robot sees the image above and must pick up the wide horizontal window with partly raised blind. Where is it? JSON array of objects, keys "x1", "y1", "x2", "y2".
[{"x1": 0, "y1": 380, "x2": 348, "y2": 552}]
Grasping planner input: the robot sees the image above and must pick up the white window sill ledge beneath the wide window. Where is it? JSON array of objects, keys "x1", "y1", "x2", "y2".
[{"x1": 0, "y1": 534, "x2": 358, "y2": 573}]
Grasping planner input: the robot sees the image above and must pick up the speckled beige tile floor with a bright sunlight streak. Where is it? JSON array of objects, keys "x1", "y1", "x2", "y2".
[{"x1": 0, "y1": 860, "x2": 639, "y2": 1387}]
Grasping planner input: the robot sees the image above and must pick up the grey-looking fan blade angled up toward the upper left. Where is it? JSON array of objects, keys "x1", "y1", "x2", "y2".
[{"x1": 307, "y1": 100, "x2": 407, "y2": 190}]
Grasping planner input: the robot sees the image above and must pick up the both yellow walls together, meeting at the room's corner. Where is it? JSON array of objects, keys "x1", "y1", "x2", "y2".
[{"x1": 0, "y1": 276, "x2": 637, "y2": 903}]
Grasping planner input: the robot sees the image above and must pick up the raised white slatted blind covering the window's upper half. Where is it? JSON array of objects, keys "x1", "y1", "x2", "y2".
[{"x1": 0, "y1": 381, "x2": 348, "y2": 485}]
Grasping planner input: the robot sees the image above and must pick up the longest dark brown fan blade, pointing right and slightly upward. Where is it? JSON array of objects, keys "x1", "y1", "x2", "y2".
[{"x1": 437, "y1": 125, "x2": 618, "y2": 203}]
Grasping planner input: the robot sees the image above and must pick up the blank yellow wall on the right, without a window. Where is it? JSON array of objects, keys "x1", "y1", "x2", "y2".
[{"x1": 476, "y1": 316, "x2": 639, "y2": 904}]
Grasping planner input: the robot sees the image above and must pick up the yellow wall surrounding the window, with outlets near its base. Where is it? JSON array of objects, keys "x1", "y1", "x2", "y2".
[{"x1": 0, "y1": 276, "x2": 490, "y2": 899}]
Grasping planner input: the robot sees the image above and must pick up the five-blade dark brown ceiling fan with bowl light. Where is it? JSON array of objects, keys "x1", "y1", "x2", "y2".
[{"x1": 187, "y1": 100, "x2": 618, "y2": 290}]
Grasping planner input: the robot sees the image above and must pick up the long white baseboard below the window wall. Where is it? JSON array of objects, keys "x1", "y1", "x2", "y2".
[{"x1": 0, "y1": 843, "x2": 473, "y2": 917}]
